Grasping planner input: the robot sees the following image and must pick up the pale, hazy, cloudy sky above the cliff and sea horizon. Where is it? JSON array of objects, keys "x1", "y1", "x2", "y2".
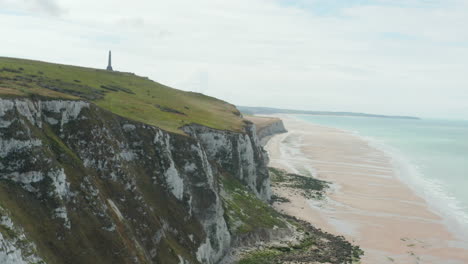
[{"x1": 0, "y1": 0, "x2": 468, "y2": 119}]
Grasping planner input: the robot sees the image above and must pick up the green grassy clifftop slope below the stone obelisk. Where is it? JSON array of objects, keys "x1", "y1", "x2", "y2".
[{"x1": 0, "y1": 57, "x2": 243, "y2": 133}]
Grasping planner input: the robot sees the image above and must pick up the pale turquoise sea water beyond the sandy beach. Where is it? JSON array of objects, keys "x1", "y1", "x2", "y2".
[{"x1": 296, "y1": 115, "x2": 468, "y2": 236}]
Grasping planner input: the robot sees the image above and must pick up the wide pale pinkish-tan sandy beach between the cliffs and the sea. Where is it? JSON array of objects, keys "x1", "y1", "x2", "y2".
[{"x1": 265, "y1": 115, "x2": 468, "y2": 264}]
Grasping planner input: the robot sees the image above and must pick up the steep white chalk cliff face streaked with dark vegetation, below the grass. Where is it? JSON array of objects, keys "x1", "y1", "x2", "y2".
[{"x1": 0, "y1": 99, "x2": 271, "y2": 264}]
